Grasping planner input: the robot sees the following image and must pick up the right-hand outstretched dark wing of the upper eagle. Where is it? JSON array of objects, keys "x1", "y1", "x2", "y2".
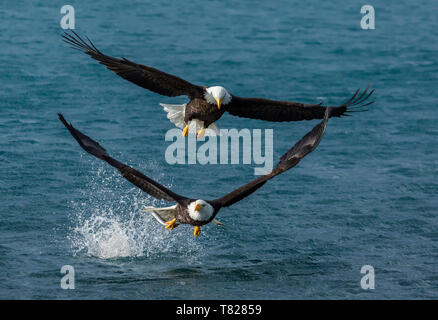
[{"x1": 224, "y1": 88, "x2": 374, "y2": 122}]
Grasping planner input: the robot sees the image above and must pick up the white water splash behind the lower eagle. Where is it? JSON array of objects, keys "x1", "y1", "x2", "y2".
[{"x1": 68, "y1": 162, "x2": 202, "y2": 259}]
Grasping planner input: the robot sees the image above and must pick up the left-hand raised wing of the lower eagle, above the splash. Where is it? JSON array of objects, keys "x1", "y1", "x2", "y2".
[{"x1": 58, "y1": 114, "x2": 187, "y2": 203}]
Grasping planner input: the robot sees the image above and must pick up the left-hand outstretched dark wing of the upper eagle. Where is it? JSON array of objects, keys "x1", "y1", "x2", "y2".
[{"x1": 62, "y1": 30, "x2": 204, "y2": 98}]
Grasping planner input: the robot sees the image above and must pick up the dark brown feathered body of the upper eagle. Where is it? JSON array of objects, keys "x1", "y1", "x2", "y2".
[{"x1": 184, "y1": 98, "x2": 225, "y2": 128}]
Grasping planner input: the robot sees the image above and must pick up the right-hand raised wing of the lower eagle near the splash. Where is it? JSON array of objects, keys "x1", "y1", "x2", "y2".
[{"x1": 211, "y1": 107, "x2": 334, "y2": 207}]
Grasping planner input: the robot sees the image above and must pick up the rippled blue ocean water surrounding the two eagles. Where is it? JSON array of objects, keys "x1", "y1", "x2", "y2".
[{"x1": 0, "y1": 0, "x2": 438, "y2": 299}]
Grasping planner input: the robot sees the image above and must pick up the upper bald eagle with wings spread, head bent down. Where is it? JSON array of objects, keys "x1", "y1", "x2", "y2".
[{"x1": 63, "y1": 31, "x2": 374, "y2": 138}]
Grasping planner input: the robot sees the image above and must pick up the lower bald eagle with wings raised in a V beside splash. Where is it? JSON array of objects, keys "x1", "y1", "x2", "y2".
[{"x1": 59, "y1": 108, "x2": 333, "y2": 237}]
